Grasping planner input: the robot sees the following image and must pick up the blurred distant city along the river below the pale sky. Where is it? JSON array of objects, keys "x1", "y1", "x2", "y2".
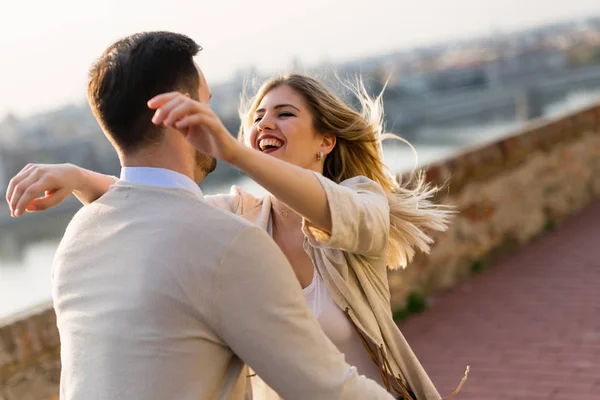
[{"x1": 0, "y1": 17, "x2": 600, "y2": 189}]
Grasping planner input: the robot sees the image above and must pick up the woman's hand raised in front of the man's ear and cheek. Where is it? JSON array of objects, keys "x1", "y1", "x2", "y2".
[{"x1": 148, "y1": 92, "x2": 242, "y2": 163}]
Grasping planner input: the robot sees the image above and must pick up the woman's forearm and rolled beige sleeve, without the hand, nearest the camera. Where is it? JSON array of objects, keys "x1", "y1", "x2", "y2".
[{"x1": 220, "y1": 146, "x2": 390, "y2": 257}]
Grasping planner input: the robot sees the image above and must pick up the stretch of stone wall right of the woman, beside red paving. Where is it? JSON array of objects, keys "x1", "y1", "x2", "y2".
[{"x1": 390, "y1": 104, "x2": 600, "y2": 310}]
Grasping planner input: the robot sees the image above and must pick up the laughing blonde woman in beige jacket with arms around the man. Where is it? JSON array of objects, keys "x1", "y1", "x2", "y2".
[{"x1": 9, "y1": 74, "x2": 464, "y2": 399}]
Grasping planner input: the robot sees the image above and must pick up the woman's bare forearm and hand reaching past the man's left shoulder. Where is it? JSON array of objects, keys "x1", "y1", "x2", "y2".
[{"x1": 6, "y1": 164, "x2": 116, "y2": 217}]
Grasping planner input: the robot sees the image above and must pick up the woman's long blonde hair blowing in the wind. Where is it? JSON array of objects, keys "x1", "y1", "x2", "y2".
[{"x1": 238, "y1": 74, "x2": 451, "y2": 269}]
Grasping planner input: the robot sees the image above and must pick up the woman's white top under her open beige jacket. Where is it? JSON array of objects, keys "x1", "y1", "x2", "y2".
[{"x1": 302, "y1": 268, "x2": 384, "y2": 386}]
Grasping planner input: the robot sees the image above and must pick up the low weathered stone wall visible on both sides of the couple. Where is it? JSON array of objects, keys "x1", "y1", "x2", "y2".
[{"x1": 0, "y1": 101, "x2": 600, "y2": 400}]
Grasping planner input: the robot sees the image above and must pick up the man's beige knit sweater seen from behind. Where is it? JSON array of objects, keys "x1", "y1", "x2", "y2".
[{"x1": 53, "y1": 182, "x2": 392, "y2": 400}]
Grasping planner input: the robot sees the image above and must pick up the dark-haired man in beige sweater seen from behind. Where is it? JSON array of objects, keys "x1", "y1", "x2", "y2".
[{"x1": 53, "y1": 32, "x2": 392, "y2": 400}]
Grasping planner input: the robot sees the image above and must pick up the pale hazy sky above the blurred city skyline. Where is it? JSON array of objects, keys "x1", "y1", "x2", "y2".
[{"x1": 0, "y1": 0, "x2": 600, "y2": 118}]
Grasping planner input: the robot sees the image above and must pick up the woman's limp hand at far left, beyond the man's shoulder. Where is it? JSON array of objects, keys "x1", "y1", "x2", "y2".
[{"x1": 6, "y1": 164, "x2": 82, "y2": 217}]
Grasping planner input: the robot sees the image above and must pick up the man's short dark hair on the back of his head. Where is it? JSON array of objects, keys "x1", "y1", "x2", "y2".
[{"x1": 88, "y1": 32, "x2": 202, "y2": 153}]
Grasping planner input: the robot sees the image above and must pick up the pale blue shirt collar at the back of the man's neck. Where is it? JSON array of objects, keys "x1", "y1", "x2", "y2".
[{"x1": 121, "y1": 167, "x2": 204, "y2": 200}]
